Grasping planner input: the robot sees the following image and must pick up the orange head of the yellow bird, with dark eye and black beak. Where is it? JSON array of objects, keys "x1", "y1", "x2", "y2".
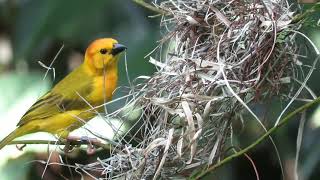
[{"x1": 85, "y1": 38, "x2": 126, "y2": 71}]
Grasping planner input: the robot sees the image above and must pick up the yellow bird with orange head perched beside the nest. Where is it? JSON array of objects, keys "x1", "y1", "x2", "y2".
[{"x1": 0, "y1": 38, "x2": 126, "y2": 149}]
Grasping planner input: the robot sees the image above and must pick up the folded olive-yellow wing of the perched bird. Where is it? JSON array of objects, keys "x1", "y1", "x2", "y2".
[{"x1": 17, "y1": 66, "x2": 92, "y2": 126}]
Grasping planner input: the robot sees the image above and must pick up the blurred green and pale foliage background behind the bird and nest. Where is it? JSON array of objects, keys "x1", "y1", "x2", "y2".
[{"x1": 0, "y1": 0, "x2": 320, "y2": 180}]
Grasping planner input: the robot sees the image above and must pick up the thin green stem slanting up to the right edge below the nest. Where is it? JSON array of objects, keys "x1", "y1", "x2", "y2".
[{"x1": 191, "y1": 97, "x2": 320, "y2": 179}]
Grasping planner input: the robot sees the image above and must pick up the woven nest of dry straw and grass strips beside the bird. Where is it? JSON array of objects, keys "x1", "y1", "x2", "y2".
[{"x1": 78, "y1": 0, "x2": 316, "y2": 179}]
